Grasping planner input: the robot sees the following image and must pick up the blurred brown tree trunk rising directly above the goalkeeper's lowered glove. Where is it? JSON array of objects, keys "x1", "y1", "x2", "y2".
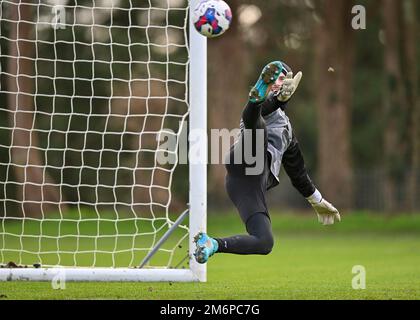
[{"x1": 314, "y1": 0, "x2": 355, "y2": 208}]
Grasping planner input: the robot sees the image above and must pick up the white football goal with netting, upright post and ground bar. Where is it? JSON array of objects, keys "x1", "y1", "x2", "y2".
[{"x1": 0, "y1": 0, "x2": 206, "y2": 281}]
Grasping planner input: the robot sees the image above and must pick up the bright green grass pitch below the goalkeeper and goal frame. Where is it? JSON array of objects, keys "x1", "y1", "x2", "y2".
[{"x1": 0, "y1": 213, "x2": 420, "y2": 300}]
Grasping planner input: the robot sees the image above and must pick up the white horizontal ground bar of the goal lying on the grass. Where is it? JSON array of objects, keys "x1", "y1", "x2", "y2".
[{"x1": 0, "y1": 267, "x2": 200, "y2": 282}]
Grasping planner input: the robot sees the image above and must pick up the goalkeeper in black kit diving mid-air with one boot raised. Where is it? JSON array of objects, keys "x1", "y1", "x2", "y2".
[{"x1": 194, "y1": 61, "x2": 340, "y2": 263}]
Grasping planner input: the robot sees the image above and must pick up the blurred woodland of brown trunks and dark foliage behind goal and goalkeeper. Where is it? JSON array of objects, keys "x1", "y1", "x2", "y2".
[{"x1": 0, "y1": 0, "x2": 420, "y2": 215}]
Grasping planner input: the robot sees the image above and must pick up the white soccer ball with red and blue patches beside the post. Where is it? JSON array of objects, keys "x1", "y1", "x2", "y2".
[{"x1": 192, "y1": 0, "x2": 232, "y2": 38}]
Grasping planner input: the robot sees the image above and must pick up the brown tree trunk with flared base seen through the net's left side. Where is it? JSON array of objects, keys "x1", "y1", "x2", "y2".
[{"x1": 5, "y1": 2, "x2": 60, "y2": 217}]
